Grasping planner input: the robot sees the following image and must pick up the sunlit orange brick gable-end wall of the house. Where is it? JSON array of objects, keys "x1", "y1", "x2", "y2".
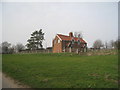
[{"x1": 53, "y1": 36, "x2": 62, "y2": 53}]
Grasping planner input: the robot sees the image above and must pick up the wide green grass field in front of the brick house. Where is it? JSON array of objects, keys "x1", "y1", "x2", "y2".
[{"x1": 2, "y1": 54, "x2": 118, "y2": 88}]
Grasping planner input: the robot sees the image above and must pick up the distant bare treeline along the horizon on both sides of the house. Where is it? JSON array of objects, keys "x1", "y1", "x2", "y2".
[{"x1": 0, "y1": 39, "x2": 120, "y2": 54}]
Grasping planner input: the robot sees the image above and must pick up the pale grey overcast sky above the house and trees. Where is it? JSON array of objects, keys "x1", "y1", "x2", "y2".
[{"x1": 0, "y1": 2, "x2": 118, "y2": 47}]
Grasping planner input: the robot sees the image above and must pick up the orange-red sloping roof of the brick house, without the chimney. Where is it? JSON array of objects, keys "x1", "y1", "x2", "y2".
[{"x1": 57, "y1": 34, "x2": 86, "y2": 43}]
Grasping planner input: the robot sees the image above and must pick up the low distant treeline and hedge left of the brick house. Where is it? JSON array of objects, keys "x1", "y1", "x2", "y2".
[{"x1": 0, "y1": 41, "x2": 52, "y2": 54}]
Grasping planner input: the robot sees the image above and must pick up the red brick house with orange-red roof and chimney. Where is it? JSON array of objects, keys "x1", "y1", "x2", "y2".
[{"x1": 52, "y1": 32, "x2": 87, "y2": 53}]
